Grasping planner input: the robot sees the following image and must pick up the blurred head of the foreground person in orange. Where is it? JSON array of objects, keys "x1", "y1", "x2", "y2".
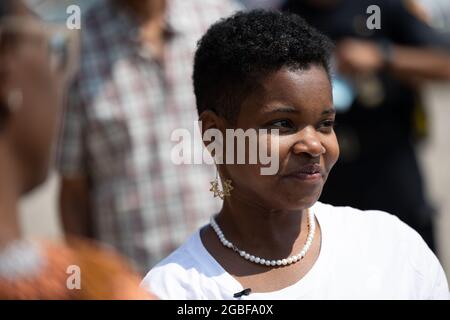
[{"x1": 0, "y1": 1, "x2": 70, "y2": 194}]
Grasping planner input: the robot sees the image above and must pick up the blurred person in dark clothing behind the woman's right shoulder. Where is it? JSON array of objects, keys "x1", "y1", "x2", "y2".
[{"x1": 285, "y1": 0, "x2": 450, "y2": 249}]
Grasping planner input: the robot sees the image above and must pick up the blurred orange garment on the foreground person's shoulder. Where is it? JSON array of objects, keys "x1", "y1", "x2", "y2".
[{"x1": 0, "y1": 239, "x2": 155, "y2": 300}]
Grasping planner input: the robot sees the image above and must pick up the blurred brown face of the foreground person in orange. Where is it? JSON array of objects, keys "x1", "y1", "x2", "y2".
[{"x1": 0, "y1": 2, "x2": 63, "y2": 192}]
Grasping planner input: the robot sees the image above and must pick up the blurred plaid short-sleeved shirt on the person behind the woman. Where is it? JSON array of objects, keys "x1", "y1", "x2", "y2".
[{"x1": 58, "y1": 0, "x2": 238, "y2": 271}]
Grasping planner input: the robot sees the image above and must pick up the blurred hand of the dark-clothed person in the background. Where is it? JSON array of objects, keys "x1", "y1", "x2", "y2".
[{"x1": 336, "y1": 39, "x2": 385, "y2": 75}]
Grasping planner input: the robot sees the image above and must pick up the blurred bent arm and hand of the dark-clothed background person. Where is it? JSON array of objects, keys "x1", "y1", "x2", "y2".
[{"x1": 336, "y1": 0, "x2": 450, "y2": 81}]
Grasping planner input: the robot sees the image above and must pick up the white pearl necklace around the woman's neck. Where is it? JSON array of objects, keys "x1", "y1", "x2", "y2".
[{"x1": 210, "y1": 209, "x2": 316, "y2": 267}]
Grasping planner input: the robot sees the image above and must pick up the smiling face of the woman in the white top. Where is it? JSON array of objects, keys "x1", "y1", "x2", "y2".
[{"x1": 221, "y1": 66, "x2": 339, "y2": 211}]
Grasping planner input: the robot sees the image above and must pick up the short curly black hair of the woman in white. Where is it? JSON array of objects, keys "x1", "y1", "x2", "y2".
[{"x1": 193, "y1": 10, "x2": 333, "y2": 122}]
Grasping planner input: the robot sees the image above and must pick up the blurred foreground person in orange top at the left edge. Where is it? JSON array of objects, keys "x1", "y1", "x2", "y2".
[{"x1": 0, "y1": 0, "x2": 153, "y2": 299}]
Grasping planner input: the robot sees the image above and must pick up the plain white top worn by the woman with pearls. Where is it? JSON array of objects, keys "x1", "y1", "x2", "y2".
[{"x1": 141, "y1": 202, "x2": 449, "y2": 300}]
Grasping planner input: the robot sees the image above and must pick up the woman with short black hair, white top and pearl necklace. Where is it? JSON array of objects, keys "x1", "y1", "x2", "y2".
[{"x1": 142, "y1": 11, "x2": 448, "y2": 299}]
